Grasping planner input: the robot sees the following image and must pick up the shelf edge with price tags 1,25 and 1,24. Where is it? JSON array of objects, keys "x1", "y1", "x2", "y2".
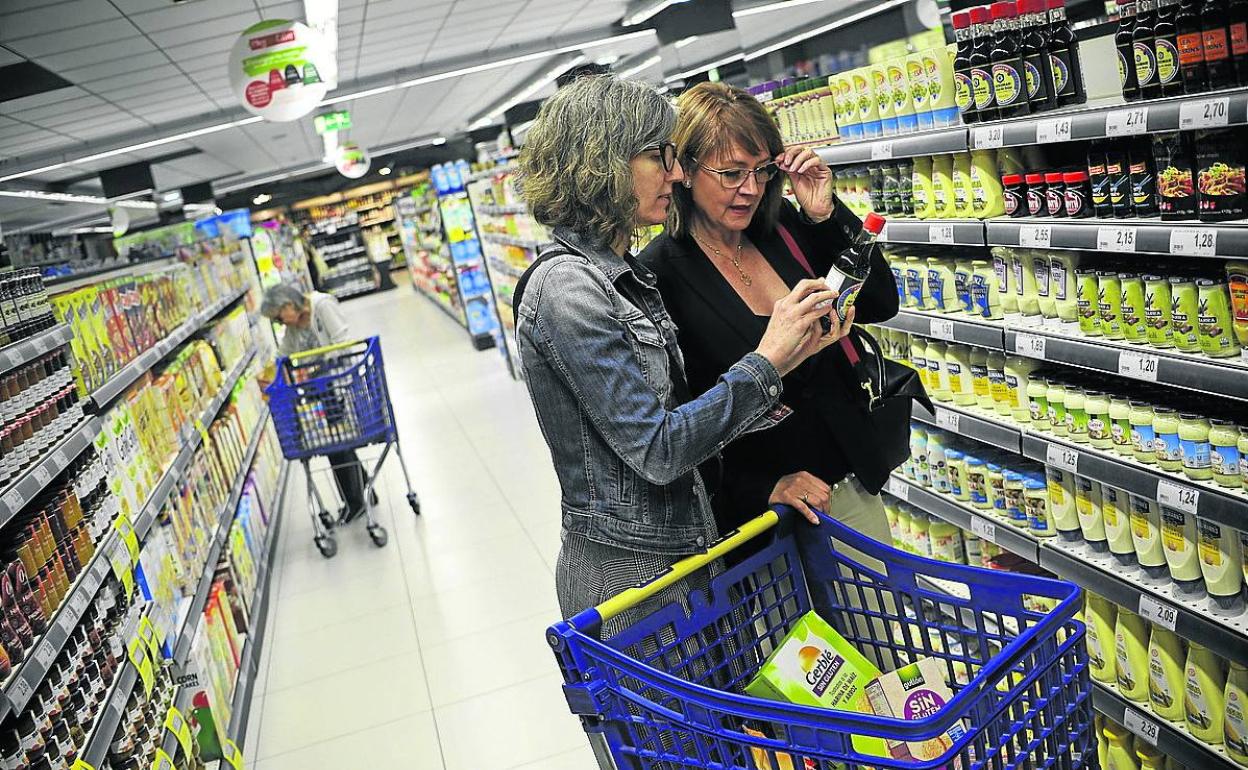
[{"x1": 1022, "y1": 431, "x2": 1248, "y2": 529}]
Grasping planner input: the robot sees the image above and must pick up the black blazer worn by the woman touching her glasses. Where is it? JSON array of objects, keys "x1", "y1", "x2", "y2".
[{"x1": 640, "y1": 201, "x2": 910, "y2": 532}]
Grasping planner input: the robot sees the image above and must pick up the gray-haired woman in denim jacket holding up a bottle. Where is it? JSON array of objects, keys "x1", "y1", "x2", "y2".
[{"x1": 513, "y1": 76, "x2": 836, "y2": 636}]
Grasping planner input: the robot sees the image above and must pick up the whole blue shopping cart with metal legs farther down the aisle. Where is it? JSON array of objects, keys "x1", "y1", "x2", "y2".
[{"x1": 265, "y1": 337, "x2": 421, "y2": 558}]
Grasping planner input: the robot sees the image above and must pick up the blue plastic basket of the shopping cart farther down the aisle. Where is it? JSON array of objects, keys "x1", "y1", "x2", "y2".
[{"x1": 267, "y1": 337, "x2": 397, "y2": 459}]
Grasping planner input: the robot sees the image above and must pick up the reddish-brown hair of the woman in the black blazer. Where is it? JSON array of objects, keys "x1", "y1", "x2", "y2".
[{"x1": 668, "y1": 82, "x2": 785, "y2": 237}]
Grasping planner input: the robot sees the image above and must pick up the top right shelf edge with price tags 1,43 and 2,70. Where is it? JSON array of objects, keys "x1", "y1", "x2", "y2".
[{"x1": 968, "y1": 89, "x2": 1248, "y2": 155}]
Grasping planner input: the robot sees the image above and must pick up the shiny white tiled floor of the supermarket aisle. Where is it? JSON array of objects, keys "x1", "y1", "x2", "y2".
[{"x1": 245, "y1": 275, "x2": 595, "y2": 770}]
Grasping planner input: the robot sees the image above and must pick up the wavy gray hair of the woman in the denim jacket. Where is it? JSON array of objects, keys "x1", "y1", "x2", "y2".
[{"x1": 518, "y1": 75, "x2": 676, "y2": 243}]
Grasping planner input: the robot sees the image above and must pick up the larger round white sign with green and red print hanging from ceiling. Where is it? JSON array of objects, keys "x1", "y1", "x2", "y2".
[{"x1": 230, "y1": 19, "x2": 329, "y2": 122}]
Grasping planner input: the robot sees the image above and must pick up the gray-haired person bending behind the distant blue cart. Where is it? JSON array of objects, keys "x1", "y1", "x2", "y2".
[{"x1": 260, "y1": 283, "x2": 364, "y2": 520}]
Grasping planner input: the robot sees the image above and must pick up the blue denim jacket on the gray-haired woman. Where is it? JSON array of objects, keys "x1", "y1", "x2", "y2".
[{"x1": 515, "y1": 228, "x2": 784, "y2": 555}]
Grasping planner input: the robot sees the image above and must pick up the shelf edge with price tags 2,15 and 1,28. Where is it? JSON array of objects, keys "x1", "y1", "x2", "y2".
[{"x1": 987, "y1": 218, "x2": 1248, "y2": 258}]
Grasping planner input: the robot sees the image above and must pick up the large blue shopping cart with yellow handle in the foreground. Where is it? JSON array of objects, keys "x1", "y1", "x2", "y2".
[{"x1": 547, "y1": 508, "x2": 1097, "y2": 770}]
